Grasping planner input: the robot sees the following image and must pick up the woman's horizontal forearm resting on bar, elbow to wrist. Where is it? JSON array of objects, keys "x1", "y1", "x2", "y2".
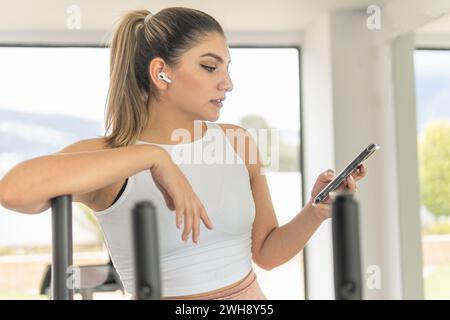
[{"x1": 0, "y1": 145, "x2": 162, "y2": 213}]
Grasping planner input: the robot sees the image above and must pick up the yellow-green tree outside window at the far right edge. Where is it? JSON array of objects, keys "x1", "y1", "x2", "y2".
[{"x1": 419, "y1": 119, "x2": 450, "y2": 217}]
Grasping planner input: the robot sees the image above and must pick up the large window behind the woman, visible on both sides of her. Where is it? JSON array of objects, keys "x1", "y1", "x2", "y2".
[{"x1": 0, "y1": 47, "x2": 304, "y2": 299}]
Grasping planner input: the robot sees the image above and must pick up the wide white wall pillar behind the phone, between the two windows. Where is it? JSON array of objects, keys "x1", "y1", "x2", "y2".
[{"x1": 302, "y1": 11, "x2": 423, "y2": 299}]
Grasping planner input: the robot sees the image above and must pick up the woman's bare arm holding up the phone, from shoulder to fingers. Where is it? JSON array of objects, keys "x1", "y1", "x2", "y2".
[{"x1": 221, "y1": 124, "x2": 366, "y2": 270}]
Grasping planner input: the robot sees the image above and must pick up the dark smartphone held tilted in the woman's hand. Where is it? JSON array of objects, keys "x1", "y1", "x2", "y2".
[{"x1": 314, "y1": 143, "x2": 380, "y2": 203}]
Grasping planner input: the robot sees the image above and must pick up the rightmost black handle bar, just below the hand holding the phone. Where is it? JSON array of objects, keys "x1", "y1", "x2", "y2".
[{"x1": 332, "y1": 193, "x2": 362, "y2": 300}]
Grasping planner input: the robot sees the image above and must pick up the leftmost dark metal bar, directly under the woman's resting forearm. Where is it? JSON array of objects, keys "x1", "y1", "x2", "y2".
[{"x1": 51, "y1": 195, "x2": 73, "y2": 300}]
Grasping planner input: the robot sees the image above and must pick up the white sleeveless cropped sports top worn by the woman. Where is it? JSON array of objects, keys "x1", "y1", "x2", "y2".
[{"x1": 94, "y1": 122, "x2": 255, "y2": 297}]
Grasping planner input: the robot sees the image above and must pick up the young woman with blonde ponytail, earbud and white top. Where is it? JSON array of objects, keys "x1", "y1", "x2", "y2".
[{"x1": 0, "y1": 7, "x2": 366, "y2": 299}]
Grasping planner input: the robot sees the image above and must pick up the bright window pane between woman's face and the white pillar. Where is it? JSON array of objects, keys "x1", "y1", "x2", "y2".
[{"x1": 219, "y1": 48, "x2": 304, "y2": 299}]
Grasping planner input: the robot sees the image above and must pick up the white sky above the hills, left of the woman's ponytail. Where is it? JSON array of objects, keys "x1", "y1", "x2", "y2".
[{"x1": 0, "y1": 47, "x2": 109, "y2": 123}]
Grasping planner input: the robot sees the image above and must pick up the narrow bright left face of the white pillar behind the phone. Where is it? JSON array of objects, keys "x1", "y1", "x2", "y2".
[{"x1": 301, "y1": 14, "x2": 335, "y2": 299}]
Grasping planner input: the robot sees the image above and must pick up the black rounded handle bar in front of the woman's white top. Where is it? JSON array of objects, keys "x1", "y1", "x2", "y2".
[{"x1": 132, "y1": 201, "x2": 161, "y2": 300}]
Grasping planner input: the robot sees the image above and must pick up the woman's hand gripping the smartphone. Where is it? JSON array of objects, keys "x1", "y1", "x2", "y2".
[{"x1": 308, "y1": 164, "x2": 367, "y2": 220}]
